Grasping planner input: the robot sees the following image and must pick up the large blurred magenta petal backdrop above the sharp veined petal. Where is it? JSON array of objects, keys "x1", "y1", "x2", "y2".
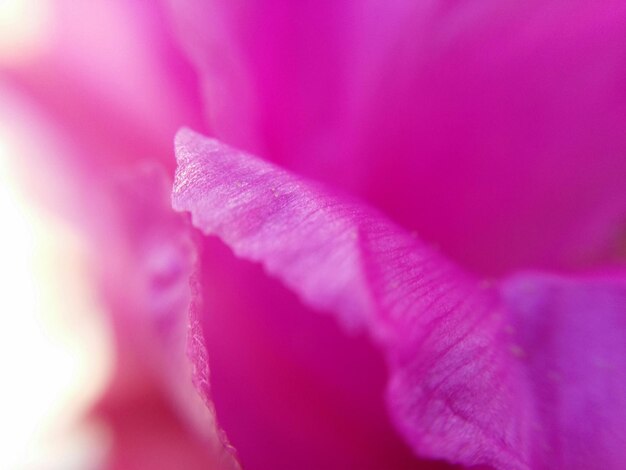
[{"x1": 165, "y1": 0, "x2": 626, "y2": 273}]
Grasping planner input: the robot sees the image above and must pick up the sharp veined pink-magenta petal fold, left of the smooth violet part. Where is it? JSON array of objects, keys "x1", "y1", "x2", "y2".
[{"x1": 173, "y1": 126, "x2": 527, "y2": 468}]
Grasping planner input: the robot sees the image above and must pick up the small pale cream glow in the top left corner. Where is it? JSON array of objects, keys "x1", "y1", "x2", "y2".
[{"x1": 0, "y1": 0, "x2": 52, "y2": 65}]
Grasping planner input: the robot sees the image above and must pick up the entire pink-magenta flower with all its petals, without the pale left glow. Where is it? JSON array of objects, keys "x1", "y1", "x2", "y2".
[{"x1": 1, "y1": 0, "x2": 626, "y2": 469}]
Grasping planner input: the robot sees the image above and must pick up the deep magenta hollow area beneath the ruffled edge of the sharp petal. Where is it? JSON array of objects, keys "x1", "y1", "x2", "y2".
[{"x1": 193, "y1": 237, "x2": 450, "y2": 470}]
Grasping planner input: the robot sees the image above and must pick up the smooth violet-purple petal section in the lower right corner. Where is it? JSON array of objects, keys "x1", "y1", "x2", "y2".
[{"x1": 502, "y1": 272, "x2": 626, "y2": 470}]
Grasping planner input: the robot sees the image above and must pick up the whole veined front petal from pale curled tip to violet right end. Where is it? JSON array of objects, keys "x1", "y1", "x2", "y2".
[{"x1": 173, "y1": 130, "x2": 626, "y2": 469}]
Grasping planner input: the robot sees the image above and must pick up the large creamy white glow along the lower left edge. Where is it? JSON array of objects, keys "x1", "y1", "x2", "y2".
[{"x1": 0, "y1": 129, "x2": 111, "y2": 470}]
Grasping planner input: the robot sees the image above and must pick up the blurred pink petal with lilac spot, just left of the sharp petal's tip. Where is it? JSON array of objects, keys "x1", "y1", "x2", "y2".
[{"x1": 96, "y1": 164, "x2": 239, "y2": 470}]
